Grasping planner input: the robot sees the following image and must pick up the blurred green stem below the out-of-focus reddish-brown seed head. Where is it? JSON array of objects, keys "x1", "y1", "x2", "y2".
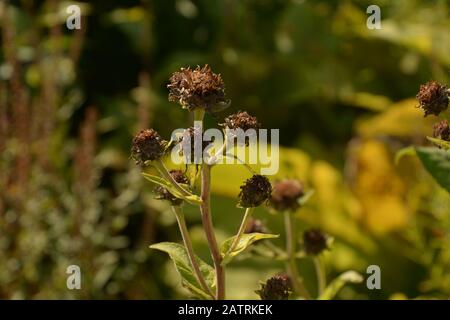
[{"x1": 284, "y1": 211, "x2": 311, "y2": 299}]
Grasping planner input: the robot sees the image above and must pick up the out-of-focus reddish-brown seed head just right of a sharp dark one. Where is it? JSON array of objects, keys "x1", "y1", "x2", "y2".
[{"x1": 270, "y1": 179, "x2": 304, "y2": 211}]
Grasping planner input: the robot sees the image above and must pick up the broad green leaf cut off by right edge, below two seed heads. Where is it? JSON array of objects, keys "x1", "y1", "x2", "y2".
[{"x1": 416, "y1": 147, "x2": 450, "y2": 192}]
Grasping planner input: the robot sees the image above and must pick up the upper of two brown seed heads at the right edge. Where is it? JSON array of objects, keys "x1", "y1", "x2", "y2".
[{"x1": 416, "y1": 81, "x2": 449, "y2": 117}]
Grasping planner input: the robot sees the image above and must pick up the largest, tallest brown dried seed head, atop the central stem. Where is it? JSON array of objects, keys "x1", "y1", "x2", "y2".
[{"x1": 167, "y1": 65, "x2": 230, "y2": 112}]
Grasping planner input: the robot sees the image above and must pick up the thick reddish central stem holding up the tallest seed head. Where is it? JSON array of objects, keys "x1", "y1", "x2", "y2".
[{"x1": 194, "y1": 108, "x2": 225, "y2": 300}]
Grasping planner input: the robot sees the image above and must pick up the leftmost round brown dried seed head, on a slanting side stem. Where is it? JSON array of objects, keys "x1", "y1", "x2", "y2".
[{"x1": 131, "y1": 129, "x2": 167, "y2": 165}]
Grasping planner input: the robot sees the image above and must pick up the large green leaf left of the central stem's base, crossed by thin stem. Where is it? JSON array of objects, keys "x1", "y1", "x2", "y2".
[{"x1": 150, "y1": 242, "x2": 215, "y2": 299}]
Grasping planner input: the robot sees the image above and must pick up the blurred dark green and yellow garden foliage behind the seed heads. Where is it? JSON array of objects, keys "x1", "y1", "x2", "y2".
[{"x1": 0, "y1": 0, "x2": 450, "y2": 299}]
